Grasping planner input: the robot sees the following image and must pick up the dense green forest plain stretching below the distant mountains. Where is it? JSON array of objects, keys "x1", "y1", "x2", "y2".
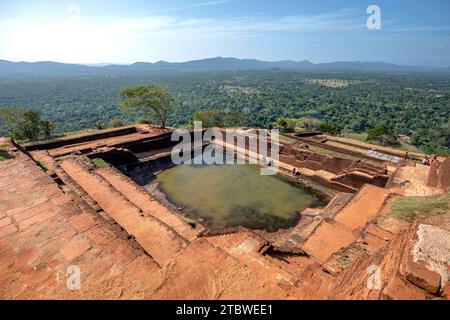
[{"x1": 0, "y1": 70, "x2": 450, "y2": 152}]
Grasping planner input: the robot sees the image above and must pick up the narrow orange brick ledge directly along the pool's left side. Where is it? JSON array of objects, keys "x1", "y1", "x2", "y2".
[{"x1": 96, "y1": 167, "x2": 203, "y2": 241}]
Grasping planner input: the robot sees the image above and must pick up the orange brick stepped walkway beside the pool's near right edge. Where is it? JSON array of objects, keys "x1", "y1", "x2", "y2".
[{"x1": 258, "y1": 184, "x2": 392, "y2": 273}]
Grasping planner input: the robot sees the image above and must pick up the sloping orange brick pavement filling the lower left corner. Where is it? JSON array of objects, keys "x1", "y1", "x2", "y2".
[{"x1": 0, "y1": 144, "x2": 167, "y2": 300}]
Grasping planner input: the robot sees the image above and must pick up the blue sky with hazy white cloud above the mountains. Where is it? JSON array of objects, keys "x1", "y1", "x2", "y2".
[{"x1": 0, "y1": 0, "x2": 450, "y2": 66}]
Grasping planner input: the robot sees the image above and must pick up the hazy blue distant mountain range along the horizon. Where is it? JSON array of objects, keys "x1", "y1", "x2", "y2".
[{"x1": 0, "y1": 57, "x2": 450, "y2": 77}]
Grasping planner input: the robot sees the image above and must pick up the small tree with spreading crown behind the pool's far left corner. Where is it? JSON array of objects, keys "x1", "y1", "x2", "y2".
[{"x1": 120, "y1": 85, "x2": 175, "y2": 128}]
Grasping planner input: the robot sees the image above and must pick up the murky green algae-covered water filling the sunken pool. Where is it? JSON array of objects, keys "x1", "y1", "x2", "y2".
[{"x1": 156, "y1": 164, "x2": 319, "y2": 231}]
